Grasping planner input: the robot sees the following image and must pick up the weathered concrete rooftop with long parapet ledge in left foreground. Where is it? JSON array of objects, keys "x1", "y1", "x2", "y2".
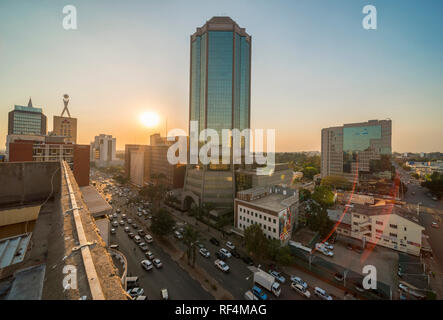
[{"x1": 0, "y1": 162, "x2": 127, "y2": 300}]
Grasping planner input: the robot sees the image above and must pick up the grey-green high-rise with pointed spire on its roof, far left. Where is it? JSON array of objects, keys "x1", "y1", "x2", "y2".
[{"x1": 8, "y1": 98, "x2": 47, "y2": 135}]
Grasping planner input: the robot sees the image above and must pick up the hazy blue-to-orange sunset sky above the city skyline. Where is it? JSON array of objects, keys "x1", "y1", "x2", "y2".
[{"x1": 0, "y1": 0, "x2": 443, "y2": 152}]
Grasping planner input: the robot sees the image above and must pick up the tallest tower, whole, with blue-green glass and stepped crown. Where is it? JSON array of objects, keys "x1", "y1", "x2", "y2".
[{"x1": 182, "y1": 17, "x2": 251, "y2": 208}]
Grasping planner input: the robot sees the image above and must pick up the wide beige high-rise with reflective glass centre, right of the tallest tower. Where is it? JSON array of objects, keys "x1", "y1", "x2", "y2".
[{"x1": 321, "y1": 119, "x2": 392, "y2": 182}]
